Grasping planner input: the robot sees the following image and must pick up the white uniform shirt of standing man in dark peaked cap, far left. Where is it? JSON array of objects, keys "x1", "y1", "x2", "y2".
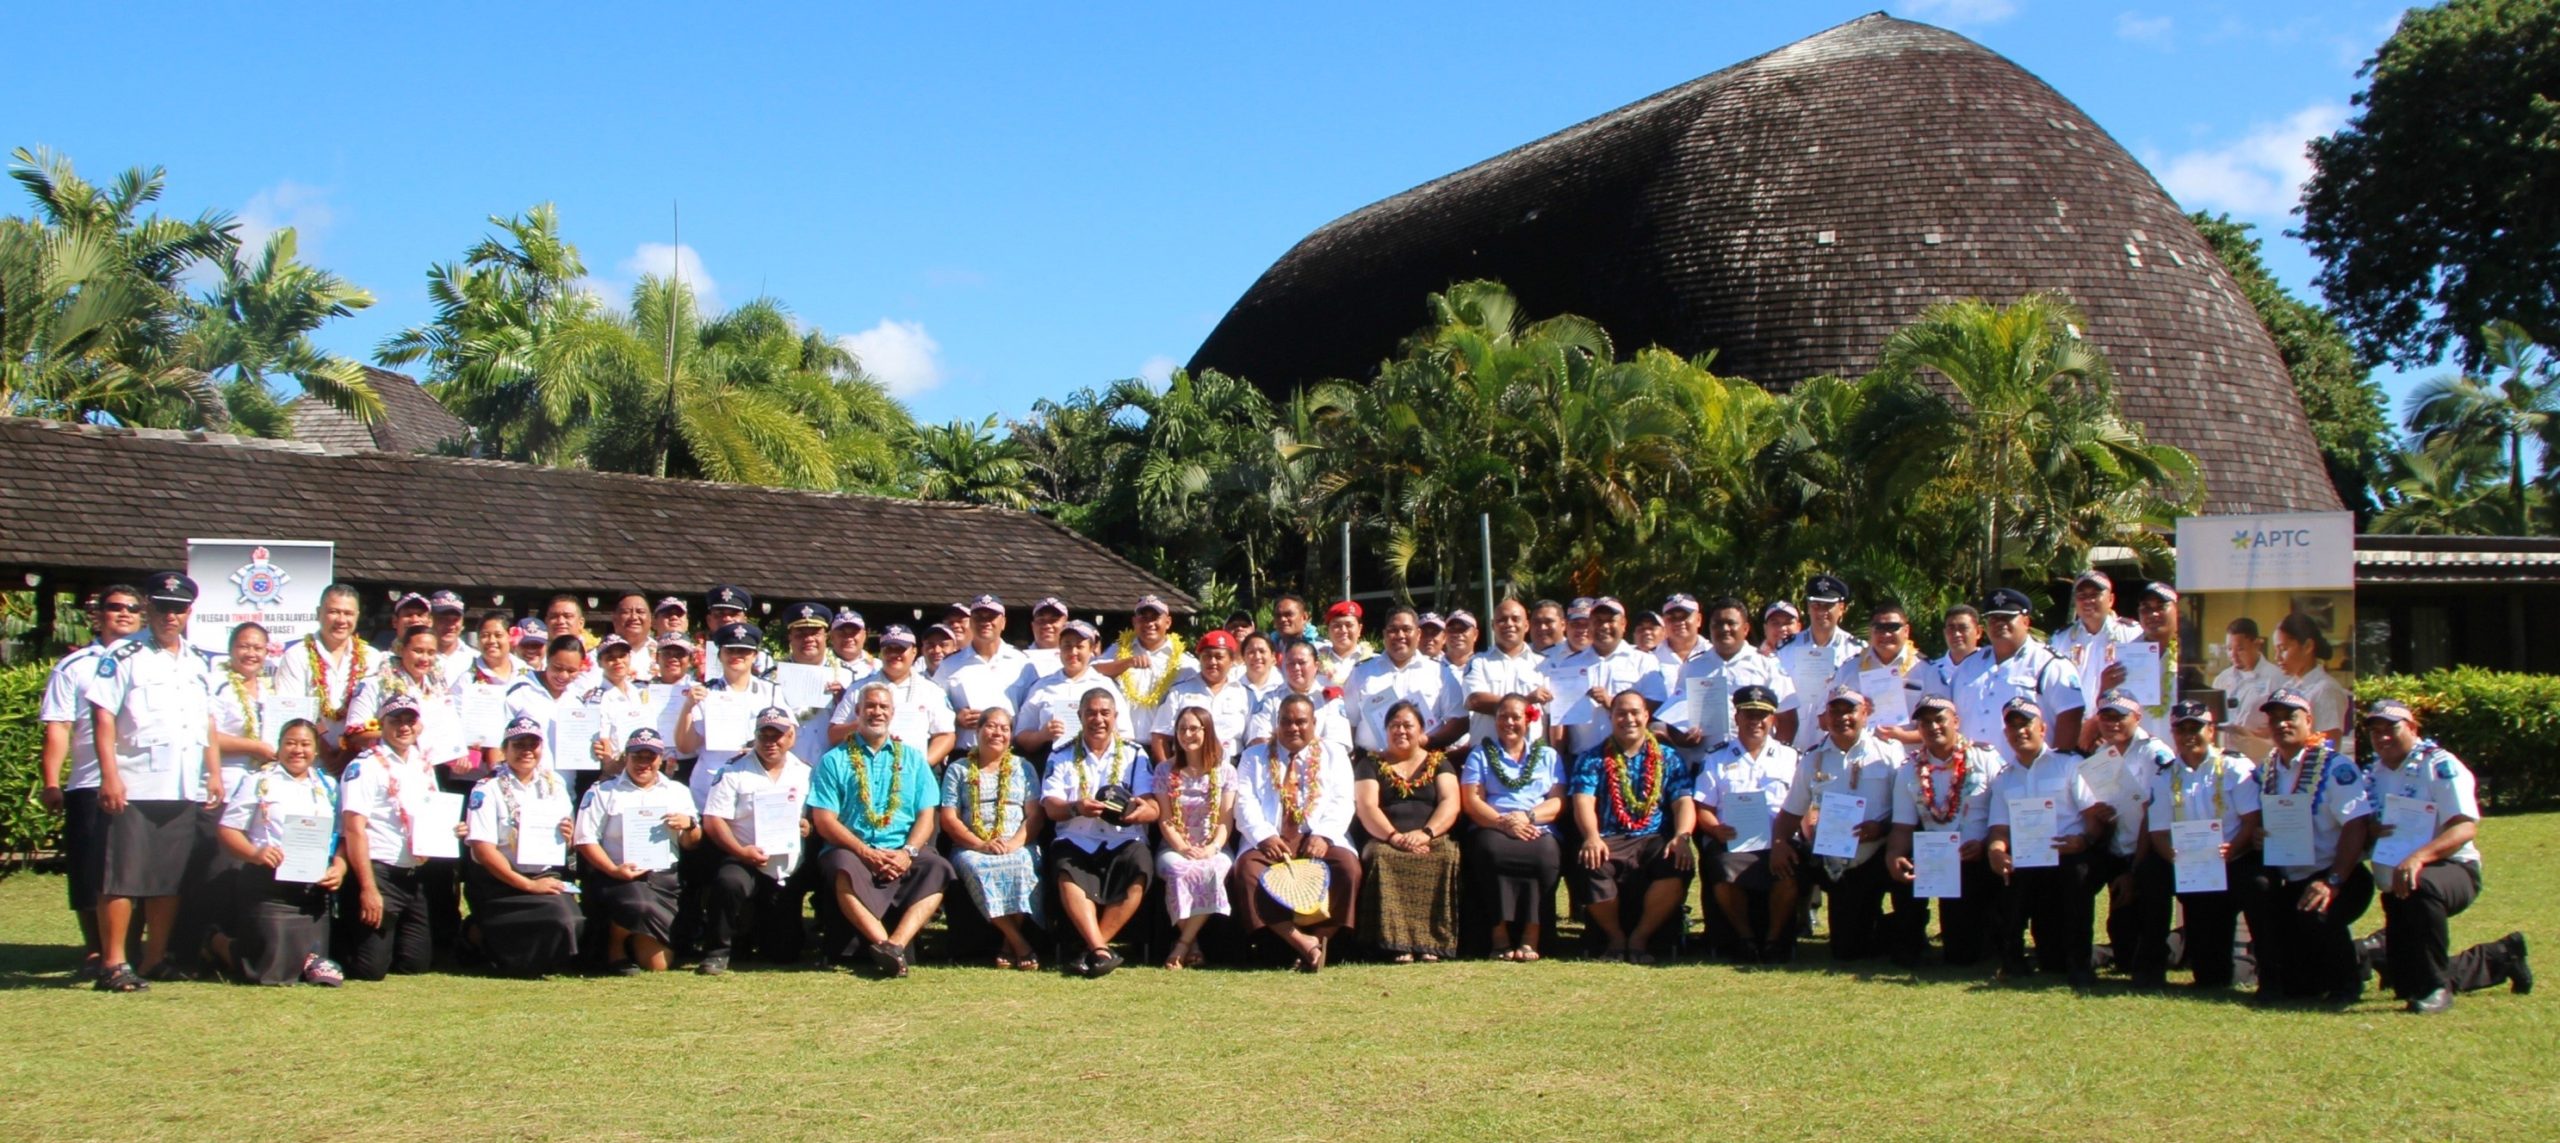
[{"x1": 87, "y1": 638, "x2": 212, "y2": 802}]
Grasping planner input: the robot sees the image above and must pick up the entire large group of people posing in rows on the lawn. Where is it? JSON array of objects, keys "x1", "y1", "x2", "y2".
[{"x1": 41, "y1": 572, "x2": 2532, "y2": 1012}]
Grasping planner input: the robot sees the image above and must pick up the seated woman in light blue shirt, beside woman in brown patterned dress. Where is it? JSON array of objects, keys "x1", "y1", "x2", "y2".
[{"x1": 1459, "y1": 695, "x2": 1564, "y2": 961}]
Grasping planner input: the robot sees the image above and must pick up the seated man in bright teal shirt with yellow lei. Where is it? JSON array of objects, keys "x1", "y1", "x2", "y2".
[{"x1": 809, "y1": 684, "x2": 952, "y2": 976}]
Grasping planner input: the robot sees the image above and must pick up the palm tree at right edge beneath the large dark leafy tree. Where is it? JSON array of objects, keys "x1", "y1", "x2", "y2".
[{"x1": 2409, "y1": 320, "x2": 2560, "y2": 536}]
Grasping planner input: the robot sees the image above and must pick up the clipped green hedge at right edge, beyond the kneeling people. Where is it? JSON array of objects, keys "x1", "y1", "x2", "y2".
[{"x1": 2355, "y1": 666, "x2": 2560, "y2": 812}]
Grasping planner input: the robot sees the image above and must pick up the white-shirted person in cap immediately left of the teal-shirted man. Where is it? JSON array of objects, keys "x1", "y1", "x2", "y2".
[{"x1": 694, "y1": 707, "x2": 809, "y2": 976}]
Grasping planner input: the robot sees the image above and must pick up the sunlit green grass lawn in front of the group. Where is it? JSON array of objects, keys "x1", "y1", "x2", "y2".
[{"x1": 0, "y1": 815, "x2": 2560, "y2": 1143}]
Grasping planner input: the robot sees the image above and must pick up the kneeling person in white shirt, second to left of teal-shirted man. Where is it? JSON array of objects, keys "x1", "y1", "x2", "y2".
[{"x1": 571, "y1": 725, "x2": 701, "y2": 976}]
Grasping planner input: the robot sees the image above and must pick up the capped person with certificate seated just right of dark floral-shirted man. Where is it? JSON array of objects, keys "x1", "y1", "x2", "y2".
[{"x1": 1697, "y1": 682, "x2": 1805, "y2": 964}]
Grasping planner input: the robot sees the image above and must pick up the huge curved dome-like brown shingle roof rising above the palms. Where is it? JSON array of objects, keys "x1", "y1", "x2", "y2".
[{"x1": 1190, "y1": 15, "x2": 2340, "y2": 513}]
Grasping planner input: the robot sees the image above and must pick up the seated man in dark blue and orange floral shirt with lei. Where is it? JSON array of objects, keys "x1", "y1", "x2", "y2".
[{"x1": 1572, "y1": 689, "x2": 1697, "y2": 964}]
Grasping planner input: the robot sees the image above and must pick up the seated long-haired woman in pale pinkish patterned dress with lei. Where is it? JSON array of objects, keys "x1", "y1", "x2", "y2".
[{"x1": 1155, "y1": 707, "x2": 1236, "y2": 969}]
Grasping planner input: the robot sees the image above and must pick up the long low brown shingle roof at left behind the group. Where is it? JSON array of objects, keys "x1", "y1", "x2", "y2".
[{"x1": 0, "y1": 418, "x2": 1196, "y2": 613}]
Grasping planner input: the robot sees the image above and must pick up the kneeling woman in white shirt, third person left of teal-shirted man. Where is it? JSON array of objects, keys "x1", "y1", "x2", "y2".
[{"x1": 463, "y1": 718, "x2": 579, "y2": 976}]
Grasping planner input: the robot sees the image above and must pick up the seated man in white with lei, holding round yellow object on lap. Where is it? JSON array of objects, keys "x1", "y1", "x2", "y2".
[{"x1": 1226, "y1": 695, "x2": 1359, "y2": 971}]
